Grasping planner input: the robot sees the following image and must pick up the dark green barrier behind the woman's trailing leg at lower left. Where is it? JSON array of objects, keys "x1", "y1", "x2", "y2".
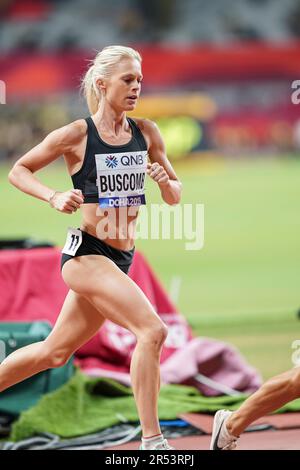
[{"x1": 0, "y1": 321, "x2": 74, "y2": 415}]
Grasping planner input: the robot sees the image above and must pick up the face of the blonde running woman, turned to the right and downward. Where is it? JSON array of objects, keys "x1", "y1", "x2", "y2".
[{"x1": 105, "y1": 59, "x2": 143, "y2": 111}]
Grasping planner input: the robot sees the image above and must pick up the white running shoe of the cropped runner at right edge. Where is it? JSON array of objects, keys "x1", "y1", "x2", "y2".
[{"x1": 210, "y1": 410, "x2": 238, "y2": 450}]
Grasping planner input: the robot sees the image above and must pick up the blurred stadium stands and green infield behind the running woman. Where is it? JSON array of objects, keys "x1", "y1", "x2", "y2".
[{"x1": 0, "y1": 0, "x2": 300, "y2": 378}]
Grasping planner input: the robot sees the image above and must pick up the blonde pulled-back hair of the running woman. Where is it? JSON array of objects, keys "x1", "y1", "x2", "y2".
[{"x1": 81, "y1": 46, "x2": 142, "y2": 114}]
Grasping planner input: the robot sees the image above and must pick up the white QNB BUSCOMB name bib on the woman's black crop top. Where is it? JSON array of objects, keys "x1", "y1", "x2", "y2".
[{"x1": 95, "y1": 151, "x2": 147, "y2": 207}]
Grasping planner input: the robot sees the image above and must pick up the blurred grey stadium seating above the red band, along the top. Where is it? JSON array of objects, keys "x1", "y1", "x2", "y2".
[{"x1": 0, "y1": 0, "x2": 300, "y2": 51}]
